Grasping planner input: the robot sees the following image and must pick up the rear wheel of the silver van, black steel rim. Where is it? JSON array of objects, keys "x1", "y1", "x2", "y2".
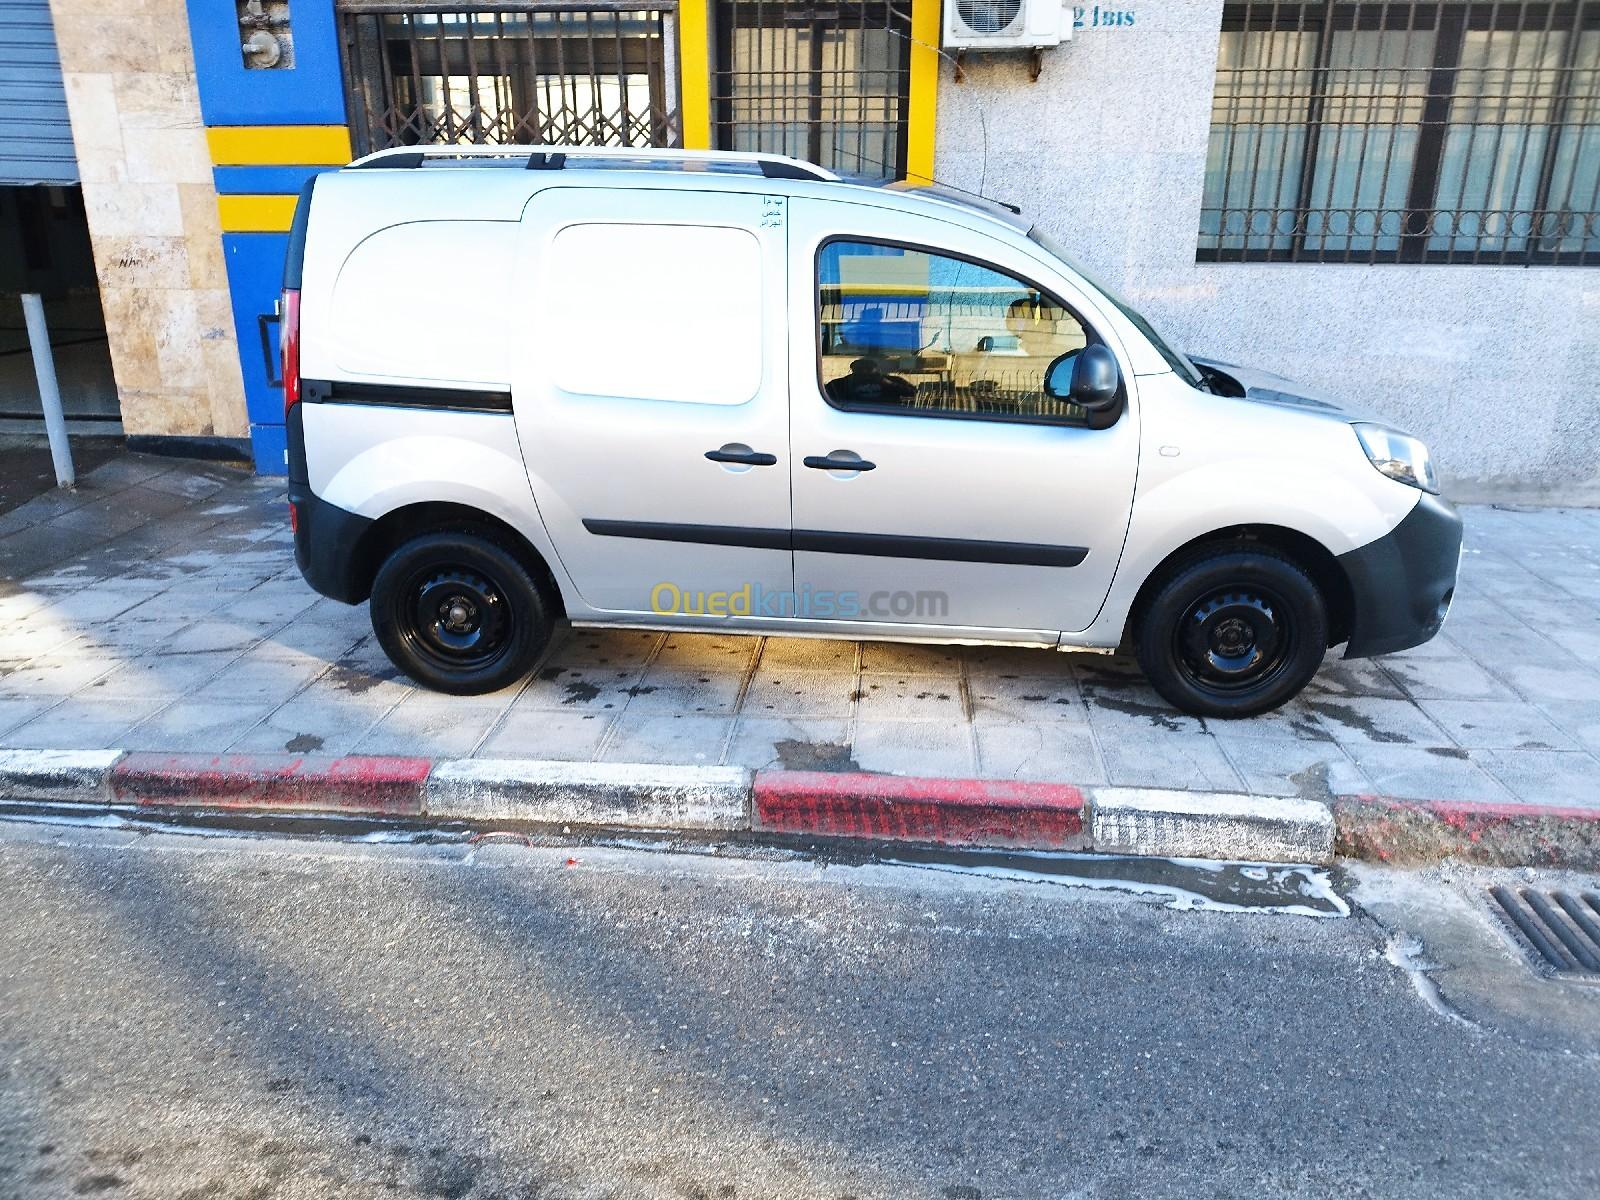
[{"x1": 371, "y1": 531, "x2": 552, "y2": 696}]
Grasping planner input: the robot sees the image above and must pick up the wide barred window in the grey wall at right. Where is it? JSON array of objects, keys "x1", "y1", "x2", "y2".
[{"x1": 1198, "y1": 0, "x2": 1600, "y2": 266}]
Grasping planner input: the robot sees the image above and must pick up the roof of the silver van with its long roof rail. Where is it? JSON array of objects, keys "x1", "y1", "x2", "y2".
[{"x1": 342, "y1": 146, "x2": 1032, "y2": 234}]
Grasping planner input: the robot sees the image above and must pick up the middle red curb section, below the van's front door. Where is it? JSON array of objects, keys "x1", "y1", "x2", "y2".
[{"x1": 752, "y1": 771, "x2": 1085, "y2": 850}]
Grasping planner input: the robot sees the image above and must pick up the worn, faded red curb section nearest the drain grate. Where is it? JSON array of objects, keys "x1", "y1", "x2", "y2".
[{"x1": 1333, "y1": 795, "x2": 1600, "y2": 869}]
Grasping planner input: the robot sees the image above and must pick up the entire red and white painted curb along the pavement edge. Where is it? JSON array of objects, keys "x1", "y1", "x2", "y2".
[{"x1": 0, "y1": 750, "x2": 1600, "y2": 870}]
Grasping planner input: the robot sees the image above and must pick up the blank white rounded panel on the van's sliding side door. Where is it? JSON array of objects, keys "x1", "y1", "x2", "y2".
[{"x1": 534, "y1": 222, "x2": 766, "y2": 405}]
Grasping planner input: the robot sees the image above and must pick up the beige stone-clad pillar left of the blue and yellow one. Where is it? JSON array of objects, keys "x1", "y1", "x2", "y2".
[{"x1": 50, "y1": 0, "x2": 250, "y2": 438}]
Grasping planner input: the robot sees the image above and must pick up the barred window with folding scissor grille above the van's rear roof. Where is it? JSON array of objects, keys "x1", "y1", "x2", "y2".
[{"x1": 339, "y1": 0, "x2": 680, "y2": 154}]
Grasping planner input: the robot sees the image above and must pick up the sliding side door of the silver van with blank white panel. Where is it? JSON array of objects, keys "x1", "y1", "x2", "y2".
[{"x1": 512, "y1": 186, "x2": 794, "y2": 621}]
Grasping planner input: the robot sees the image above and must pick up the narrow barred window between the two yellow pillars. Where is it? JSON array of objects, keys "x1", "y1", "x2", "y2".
[{"x1": 712, "y1": 0, "x2": 910, "y2": 178}]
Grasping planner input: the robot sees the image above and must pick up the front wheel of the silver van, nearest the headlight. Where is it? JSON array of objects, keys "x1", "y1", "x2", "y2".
[{"x1": 1134, "y1": 547, "x2": 1328, "y2": 718}]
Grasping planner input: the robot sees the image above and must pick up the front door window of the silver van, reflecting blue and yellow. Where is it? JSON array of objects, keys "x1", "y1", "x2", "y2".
[{"x1": 818, "y1": 242, "x2": 1090, "y2": 424}]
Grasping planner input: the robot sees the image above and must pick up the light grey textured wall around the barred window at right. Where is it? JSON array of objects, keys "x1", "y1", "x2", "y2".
[{"x1": 934, "y1": 0, "x2": 1600, "y2": 504}]
